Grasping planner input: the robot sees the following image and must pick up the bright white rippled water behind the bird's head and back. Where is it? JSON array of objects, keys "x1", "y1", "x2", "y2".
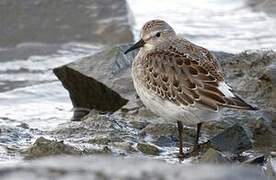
[{"x1": 128, "y1": 0, "x2": 276, "y2": 53}]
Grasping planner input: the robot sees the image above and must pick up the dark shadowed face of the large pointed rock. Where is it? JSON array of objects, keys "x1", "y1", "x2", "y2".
[{"x1": 54, "y1": 67, "x2": 127, "y2": 120}]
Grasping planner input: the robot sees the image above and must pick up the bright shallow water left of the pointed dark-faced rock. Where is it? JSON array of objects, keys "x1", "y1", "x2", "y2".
[{"x1": 0, "y1": 43, "x2": 102, "y2": 164}]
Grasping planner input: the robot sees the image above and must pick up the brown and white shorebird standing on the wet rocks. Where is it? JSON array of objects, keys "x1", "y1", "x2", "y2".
[{"x1": 125, "y1": 20, "x2": 256, "y2": 160}]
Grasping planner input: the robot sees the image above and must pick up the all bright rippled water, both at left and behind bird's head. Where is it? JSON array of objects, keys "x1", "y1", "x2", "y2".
[{"x1": 0, "y1": 0, "x2": 276, "y2": 163}]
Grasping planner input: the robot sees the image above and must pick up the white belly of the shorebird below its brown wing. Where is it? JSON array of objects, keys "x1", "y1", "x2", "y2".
[{"x1": 133, "y1": 73, "x2": 218, "y2": 125}]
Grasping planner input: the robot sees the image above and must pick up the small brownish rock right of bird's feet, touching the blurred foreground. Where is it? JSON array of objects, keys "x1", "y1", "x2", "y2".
[{"x1": 199, "y1": 148, "x2": 230, "y2": 164}]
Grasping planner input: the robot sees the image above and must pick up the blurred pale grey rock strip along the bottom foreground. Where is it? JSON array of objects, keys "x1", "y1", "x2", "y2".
[{"x1": 0, "y1": 156, "x2": 267, "y2": 180}]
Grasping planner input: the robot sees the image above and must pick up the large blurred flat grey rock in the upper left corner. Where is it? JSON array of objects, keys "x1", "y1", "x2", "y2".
[{"x1": 0, "y1": 0, "x2": 133, "y2": 46}]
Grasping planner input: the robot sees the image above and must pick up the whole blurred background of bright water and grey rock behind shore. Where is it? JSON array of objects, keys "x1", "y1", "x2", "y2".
[{"x1": 0, "y1": 0, "x2": 276, "y2": 163}]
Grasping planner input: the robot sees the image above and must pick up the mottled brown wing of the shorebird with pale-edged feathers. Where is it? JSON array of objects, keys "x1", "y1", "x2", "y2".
[{"x1": 142, "y1": 51, "x2": 256, "y2": 111}]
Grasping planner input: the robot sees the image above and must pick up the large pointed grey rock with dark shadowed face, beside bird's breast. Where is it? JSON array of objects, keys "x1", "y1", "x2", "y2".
[{"x1": 54, "y1": 45, "x2": 138, "y2": 120}]
